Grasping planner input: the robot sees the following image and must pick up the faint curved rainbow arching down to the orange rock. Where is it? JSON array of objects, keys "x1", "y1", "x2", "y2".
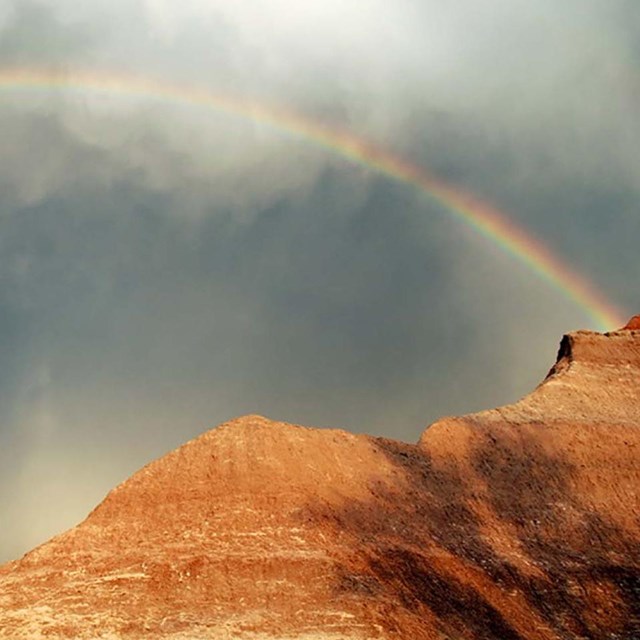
[{"x1": 0, "y1": 68, "x2": 624, "y2": 330}]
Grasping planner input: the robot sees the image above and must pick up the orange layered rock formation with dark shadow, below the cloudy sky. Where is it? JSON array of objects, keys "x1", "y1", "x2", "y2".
[{"x1": 0, "y1": 330, "x2": 640, "y2": 640}]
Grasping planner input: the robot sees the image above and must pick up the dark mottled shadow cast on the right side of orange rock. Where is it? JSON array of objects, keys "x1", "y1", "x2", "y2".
[{"x1": 307, "y1": 432, "x2": 640, "y2": 640}]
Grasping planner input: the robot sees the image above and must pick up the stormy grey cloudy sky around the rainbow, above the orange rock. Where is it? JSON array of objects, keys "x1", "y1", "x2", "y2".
[{"x1": 0, "y1": 0, "x2": 640, "y2": 561}]
